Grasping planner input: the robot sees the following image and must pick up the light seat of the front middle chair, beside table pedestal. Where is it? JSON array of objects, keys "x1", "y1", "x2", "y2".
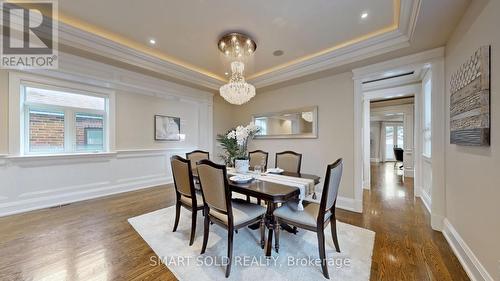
[{"x1": 210, "y1": 199, "x2": 266, "y2": 226}]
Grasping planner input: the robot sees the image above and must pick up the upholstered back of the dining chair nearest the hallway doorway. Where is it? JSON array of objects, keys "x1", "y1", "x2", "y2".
[{"x1": 319, "y1": 158, "x2": 344, "y2": 216}]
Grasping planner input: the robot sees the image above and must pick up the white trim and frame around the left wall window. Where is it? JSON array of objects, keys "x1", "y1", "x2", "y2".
[{"x1": 9, "y1": 72, "x2": 115, "y2": 157}]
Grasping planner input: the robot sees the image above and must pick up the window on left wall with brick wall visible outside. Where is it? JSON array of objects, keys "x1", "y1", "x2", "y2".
[{"x1": 21, "y1": 84, "x2": 108, "y2": 154}]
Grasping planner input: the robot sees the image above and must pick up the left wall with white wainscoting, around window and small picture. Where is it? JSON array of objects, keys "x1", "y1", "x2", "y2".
[{"x1": 0, "y1": 54, "x2": 213, "y2": 216}]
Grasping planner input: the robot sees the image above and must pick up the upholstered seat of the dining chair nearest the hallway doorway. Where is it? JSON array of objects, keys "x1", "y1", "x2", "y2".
[{"x1": 274, "y1": 202, "x2": 330, "y2": 227}]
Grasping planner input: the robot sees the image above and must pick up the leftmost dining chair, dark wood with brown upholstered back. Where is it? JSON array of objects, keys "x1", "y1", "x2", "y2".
[{"x1": 170, "y1": 155, "x2": 203, "y2": 246}]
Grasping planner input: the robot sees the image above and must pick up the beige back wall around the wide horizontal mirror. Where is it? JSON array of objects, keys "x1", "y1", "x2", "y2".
[{"x1": 229, "y1": 73, "x2": 360, "y2": 209}]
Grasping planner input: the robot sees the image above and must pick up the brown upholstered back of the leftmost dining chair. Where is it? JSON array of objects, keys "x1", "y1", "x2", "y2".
[{"x1": 170, "y1": 155, "x2": 196, "y2": 198}]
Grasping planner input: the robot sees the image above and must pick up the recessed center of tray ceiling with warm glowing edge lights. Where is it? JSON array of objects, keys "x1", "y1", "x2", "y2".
[{"x1": 59, "y1": 0, "x2": 400, "y2": 80}]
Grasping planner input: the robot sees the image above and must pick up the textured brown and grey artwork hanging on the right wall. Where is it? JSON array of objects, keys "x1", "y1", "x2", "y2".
[{"x1": 450, "y1": 46, "x2": 491, "y2": 146}]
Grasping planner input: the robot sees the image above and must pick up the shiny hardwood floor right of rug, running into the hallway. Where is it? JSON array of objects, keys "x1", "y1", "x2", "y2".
[{"x1": 337, "y1": 163, "x2": 469, "y2": 281}]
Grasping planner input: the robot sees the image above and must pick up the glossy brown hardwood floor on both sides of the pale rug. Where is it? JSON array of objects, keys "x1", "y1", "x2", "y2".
[{"x1": 0, "y1": 164, "x2": 469, "y2": 281}]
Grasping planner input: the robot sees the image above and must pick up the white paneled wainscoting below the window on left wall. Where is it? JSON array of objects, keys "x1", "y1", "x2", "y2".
[{"x1": 0, "y1": 147, "x2": 195, "y2": 217}]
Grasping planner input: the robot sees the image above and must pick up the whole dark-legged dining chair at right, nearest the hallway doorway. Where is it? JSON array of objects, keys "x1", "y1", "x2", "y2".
[{"x1": 273, "y1": 158, "x2": 343, "y2": 279}]
